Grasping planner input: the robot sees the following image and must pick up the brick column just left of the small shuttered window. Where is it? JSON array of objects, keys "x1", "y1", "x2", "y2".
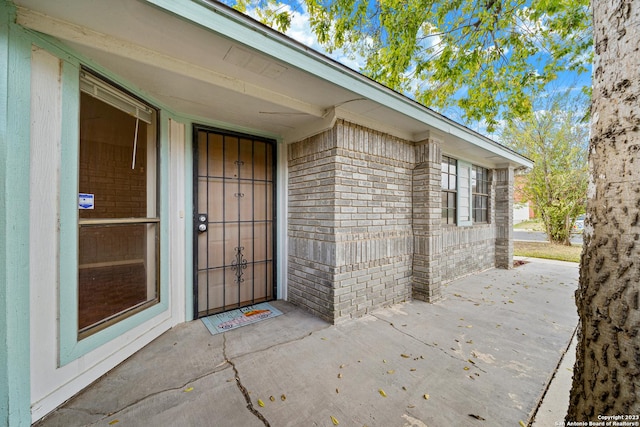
[{"x1": 412, "y1": 139, "x2": 442, "y2": 302}]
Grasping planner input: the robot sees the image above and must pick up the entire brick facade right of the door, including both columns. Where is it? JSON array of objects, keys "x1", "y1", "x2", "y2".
[{"x1": 287, "y1": 121, "x2": 512, "y2": 322}]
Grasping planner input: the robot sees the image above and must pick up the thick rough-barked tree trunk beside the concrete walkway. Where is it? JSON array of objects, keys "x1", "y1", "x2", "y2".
[{"x1": 566, "y1": 0, "x2": 640, "y2": 425}]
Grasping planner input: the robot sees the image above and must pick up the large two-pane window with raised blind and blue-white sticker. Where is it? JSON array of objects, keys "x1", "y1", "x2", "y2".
[{"x1": 78, "y1": 71, "x2": 160, "y2": 338}]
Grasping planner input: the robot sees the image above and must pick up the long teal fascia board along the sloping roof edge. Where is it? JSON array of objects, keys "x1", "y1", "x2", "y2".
[{"x1": 144, "y1": 0, "x2": 533, "y2": 167}]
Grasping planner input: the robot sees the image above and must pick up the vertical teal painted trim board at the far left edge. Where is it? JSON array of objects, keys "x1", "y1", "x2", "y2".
[{"x1": 0, "y1": 1, "x2": 31, "y2": 426}]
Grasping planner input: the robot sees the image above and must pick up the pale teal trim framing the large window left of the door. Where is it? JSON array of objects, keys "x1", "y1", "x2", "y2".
[{"x1": 59, "y1": 62, "x2": 170, "y2": 366}]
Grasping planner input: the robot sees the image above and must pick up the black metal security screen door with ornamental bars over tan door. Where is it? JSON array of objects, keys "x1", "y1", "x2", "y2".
[{"x1": 194, "y1": 127, "x2": 275, "y2": 317}]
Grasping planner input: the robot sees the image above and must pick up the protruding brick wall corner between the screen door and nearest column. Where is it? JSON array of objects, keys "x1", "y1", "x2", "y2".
[{"x1": 289, "y1": 121, "x2": 414, "y2": 322}]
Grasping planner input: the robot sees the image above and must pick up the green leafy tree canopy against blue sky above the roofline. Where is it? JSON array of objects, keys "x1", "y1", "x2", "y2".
[{"x1": 229, "y1": 0, "x2": 592, "y2": 131}]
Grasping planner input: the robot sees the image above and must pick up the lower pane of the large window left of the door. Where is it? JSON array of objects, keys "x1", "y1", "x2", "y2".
[{"x1": 78, "y1": 224, "x2": 158, "y2": 331}]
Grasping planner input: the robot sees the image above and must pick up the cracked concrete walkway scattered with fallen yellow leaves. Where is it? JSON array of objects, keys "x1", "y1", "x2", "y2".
[{"x1": 38, "y1": 259, "x2": 578, "y2": 427}]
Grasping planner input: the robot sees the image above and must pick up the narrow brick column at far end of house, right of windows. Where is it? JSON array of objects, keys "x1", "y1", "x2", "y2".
[{"x1": 494, "y1": 167, "x2": 514, "y2": 269}]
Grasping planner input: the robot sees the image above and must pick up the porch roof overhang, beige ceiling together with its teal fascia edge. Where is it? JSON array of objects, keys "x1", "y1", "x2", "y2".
[{"x1": 14, "y1": 0, "x2": 527, "y2": 167}]
